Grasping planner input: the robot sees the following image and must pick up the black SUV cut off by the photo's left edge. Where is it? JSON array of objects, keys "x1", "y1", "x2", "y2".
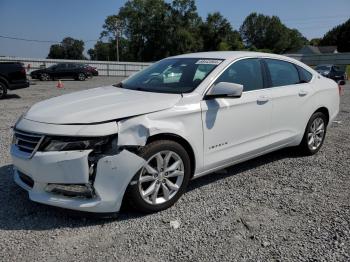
[{"x1": 0, "y1": 62, "x2": 29, "y2": 99}]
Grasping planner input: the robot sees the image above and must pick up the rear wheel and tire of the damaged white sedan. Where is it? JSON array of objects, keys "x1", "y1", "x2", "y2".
[{"x1": 299, "y1": 112, "x2": 327, "y2": 156}]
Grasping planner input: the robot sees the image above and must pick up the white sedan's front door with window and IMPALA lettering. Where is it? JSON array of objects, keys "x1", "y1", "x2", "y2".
[{"x1": 201, "y1": 58, "x2": 272, "y2": 169}]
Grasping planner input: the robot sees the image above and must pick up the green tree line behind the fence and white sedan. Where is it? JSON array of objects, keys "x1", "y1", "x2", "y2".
[{"x1": 48, "y1": 0, "x2": 350, "y2": 61}]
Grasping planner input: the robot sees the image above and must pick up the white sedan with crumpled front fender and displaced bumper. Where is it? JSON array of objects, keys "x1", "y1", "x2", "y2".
[{"x1": 11, "y1": 52, "x2": 339, "y2": 213}]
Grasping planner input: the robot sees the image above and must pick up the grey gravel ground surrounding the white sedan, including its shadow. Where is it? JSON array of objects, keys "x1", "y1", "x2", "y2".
[{"x1": 0, "y1": 78, "x2": 350, "y2": 261}]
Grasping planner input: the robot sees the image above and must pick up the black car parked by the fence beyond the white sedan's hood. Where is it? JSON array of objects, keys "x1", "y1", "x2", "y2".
[{"x1": 30, "y1": 63, "x2": 92, "y2": 81}]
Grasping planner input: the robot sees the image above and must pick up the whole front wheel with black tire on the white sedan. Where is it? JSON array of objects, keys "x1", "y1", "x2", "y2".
[{"x1": 127, "y1": 140, "x2": 191, "y2": 213}]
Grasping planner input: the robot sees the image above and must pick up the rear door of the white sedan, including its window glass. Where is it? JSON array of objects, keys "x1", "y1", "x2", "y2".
[{"x1": 264, "y1": 59, "x2": 313, "y2": 145}]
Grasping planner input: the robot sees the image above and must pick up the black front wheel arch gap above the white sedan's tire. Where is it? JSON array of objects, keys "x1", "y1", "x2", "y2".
[{"x1": 146, "y1": 133, "x2": 196, "y2": 177}]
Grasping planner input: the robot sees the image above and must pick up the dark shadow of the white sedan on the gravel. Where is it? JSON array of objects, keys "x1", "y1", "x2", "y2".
[{"x1": 0, "y1": 149, "x2": 298, "y2": 230}]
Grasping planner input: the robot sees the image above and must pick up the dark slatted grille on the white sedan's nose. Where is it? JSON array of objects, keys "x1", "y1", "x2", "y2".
[{"x1": 14, "y1": 130, "x2": 44, "y2": 157}]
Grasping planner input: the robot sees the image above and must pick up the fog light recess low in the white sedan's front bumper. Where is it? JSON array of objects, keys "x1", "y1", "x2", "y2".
[{"x1": 46, "y1": 184, "x2": 93, "y2": 198}]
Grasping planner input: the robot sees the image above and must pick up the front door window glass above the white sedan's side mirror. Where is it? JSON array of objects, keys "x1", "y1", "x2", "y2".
[{"x1": 215, "y1": 58, "x2": 264, "y2": 91}]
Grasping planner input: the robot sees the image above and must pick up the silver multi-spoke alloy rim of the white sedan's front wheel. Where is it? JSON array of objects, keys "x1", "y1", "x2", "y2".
[{"x1": 138, "y1": 150, "x2": 184, "y2": 205}]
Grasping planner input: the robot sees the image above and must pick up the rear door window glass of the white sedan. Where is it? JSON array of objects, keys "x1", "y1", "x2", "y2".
[{"x1": 265, "y1": 59, "x2": 300, "y2": 87}]
